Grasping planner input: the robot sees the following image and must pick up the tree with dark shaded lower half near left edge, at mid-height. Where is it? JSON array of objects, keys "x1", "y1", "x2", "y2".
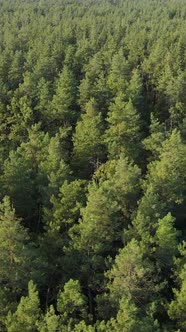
[{"x1": 1, "y1": 125, "x2": 49, "y2": 228}]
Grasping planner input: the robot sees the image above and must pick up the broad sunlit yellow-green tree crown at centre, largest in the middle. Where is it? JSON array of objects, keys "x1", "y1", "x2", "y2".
[{"x1": 74, "y1": 157, "x2": 140, "y2": 253}]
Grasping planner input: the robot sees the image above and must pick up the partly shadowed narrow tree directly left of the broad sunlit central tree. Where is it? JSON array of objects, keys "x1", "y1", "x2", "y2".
[{"x1": 42, "y1": 180, "x2": 85, "y2": 289}]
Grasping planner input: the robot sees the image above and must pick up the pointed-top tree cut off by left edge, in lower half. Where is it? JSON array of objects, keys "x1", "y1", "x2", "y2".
[{"x1": 0, "y1": 196, "x2": 29, "y2": 292}]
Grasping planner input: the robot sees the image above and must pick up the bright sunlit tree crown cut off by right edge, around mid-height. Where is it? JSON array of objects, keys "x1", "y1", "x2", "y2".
[{"x1": 147, "y1": 130, "x2": 186, "y2": 204}]
